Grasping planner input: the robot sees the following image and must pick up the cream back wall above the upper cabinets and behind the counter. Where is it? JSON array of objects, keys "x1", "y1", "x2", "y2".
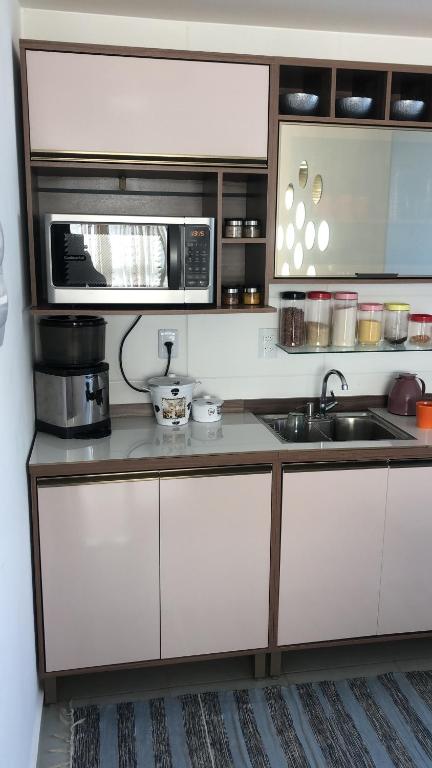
[{"x1": 22, "y1": 9, "x2": 432, "y2": 403}]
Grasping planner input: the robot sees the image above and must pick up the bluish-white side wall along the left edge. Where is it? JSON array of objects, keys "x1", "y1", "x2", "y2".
[{"x1": 0, "y1": 0, "x2": 42, "y2": 768}]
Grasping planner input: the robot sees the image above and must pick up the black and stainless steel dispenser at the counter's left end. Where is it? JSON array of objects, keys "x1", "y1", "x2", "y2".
[{"x1": 34, "y1": 316, "x2": 111, "y2": 438}]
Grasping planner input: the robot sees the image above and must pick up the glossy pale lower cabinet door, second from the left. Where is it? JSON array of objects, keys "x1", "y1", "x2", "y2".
[{"x1": 160, "y1": 472, "x2": 271, "y2": 658}]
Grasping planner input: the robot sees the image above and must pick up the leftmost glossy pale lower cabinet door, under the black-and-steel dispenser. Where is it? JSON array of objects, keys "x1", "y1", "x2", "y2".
[{"x1": 38, "y1": 479, "x2": 160, "y2": 672}]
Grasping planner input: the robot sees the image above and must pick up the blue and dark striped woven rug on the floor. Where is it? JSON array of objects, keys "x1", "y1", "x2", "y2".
[{"x1": 70, "y1": 672, "x2": 432, "y2": 768}]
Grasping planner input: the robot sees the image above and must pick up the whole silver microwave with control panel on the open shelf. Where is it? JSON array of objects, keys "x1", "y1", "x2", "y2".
[{"x1": 43, "y1": 214, "x2": 215, "y2": 305}]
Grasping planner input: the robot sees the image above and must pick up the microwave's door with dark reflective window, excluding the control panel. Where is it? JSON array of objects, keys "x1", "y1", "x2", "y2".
[{"x1": 48, "y1": 221, "x2": 184, "y2": 304}]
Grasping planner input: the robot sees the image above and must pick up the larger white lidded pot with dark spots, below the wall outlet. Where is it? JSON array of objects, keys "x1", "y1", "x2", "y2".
[{"x1": 147, "y1": 373, "x2": 199, "y2": 427}]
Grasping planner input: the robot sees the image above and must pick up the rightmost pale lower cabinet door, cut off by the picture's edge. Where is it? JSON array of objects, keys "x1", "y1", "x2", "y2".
[{"x1": 378, "y1": 467, "x2": 432, "y2": 635}]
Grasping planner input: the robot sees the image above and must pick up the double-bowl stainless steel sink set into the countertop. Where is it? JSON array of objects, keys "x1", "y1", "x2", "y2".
[{"x1": 257, "y1": 411, "x2": 414, "y2": 443}]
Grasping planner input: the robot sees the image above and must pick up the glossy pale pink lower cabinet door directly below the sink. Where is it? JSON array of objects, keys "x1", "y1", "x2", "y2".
[{"x1": 278, "y1": 467, "x2": 388, "y2": 645}]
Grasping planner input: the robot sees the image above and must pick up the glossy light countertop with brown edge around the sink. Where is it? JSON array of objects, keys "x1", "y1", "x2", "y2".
[{"x1": 29, "y1": 408, "x2": 432, "y2": 473}]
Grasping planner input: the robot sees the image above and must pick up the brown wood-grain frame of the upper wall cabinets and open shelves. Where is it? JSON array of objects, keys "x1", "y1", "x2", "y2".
[{"x1": 21, "y1": 40, "x2": 432, "y2": 315}]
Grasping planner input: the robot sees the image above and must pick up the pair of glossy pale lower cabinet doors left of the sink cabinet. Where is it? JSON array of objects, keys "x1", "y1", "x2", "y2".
[{"x1": 38, "y1": 467, "x2": 271, "y2": 672}]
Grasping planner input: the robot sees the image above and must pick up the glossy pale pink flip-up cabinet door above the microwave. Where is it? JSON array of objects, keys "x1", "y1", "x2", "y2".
[{"x1": 27, "y1": 51, "x2": 269, "y2": 160}]
